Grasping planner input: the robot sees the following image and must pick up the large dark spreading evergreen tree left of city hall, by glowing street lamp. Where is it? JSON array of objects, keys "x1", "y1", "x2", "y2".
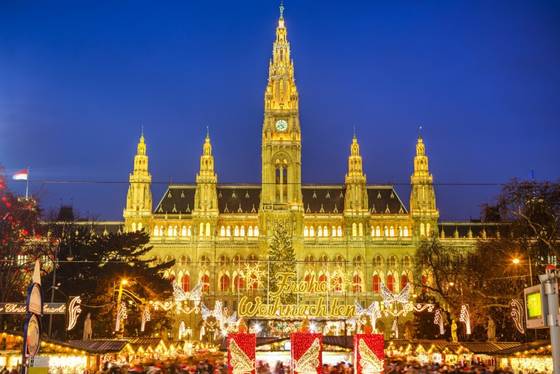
[{"x1": 45, "y1": 223, "x2": 174, "y2": 338}]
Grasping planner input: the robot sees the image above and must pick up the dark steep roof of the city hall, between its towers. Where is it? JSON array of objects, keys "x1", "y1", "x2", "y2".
[{"x1": 154, "y1": 184, "x2": 407, "y2": 215}]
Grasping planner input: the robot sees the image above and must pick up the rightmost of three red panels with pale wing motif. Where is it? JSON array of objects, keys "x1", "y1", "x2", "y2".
[{"x1": 354, "y1": 334, "x2": 385, "y2": 374}]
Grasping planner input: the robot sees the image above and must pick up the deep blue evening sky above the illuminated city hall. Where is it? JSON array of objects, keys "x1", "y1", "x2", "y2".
[{"x1": 0, "y1": 0, "x2": 560, "y2": 219}]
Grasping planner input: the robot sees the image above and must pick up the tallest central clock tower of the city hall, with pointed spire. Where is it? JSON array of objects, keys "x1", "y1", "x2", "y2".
[{"x1": 260, "y1": 6, "x2": 303, "y2": 238}]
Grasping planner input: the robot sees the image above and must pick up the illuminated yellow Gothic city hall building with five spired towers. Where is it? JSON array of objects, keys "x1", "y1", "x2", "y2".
[{"x1": 124, "y1": 8, "x2": 499, "y2": 324}]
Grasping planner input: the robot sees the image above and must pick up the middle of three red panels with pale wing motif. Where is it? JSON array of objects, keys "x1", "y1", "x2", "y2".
[{"x1": 290, "y1": 332, "x2": 323, "y2": 374}]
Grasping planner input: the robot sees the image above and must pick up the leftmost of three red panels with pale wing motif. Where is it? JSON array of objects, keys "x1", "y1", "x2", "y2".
[{"x1": 226, "y1": 333, "x2": 257, "y2": 374}]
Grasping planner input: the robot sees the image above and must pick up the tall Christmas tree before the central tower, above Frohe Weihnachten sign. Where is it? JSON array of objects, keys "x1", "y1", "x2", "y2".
[{"x1": 268, "y1": 223, "x2": 297, "y2": 304}]
